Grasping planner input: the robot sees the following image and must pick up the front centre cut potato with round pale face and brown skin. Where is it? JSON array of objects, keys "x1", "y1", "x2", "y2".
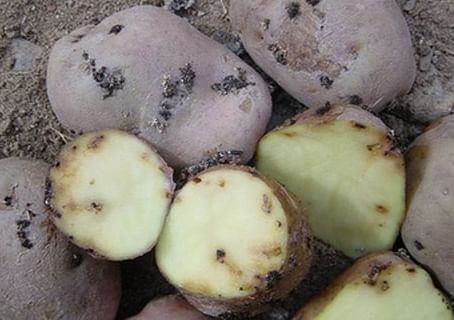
[{"x1": 156, "y1": 166, "x2": 312, "y2": 317}]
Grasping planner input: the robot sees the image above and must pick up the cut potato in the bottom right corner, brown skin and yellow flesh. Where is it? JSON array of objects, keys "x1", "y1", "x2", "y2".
[{"x1": 293, "y1": 252, "x2": 454, "y2": 320}]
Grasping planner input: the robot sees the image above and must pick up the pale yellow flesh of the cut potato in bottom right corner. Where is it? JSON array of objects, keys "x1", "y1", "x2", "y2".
[{"x1": 312, "y1": 264, "x2": 454, "y2": 320}]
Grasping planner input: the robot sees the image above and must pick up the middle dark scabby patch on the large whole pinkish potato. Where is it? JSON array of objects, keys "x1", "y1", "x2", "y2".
[{"x1": 150, "y1": 63, "x2": 196, "y2": 133}]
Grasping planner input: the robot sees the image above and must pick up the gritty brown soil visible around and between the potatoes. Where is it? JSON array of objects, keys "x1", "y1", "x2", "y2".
[{"x1": 0, "y1": 0, "x2": 454, "y2": 320}]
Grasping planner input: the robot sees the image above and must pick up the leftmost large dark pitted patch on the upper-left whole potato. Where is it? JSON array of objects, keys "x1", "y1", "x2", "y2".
[{"x1": 82, "y1": 51, "x2": 126, "y2": 99}]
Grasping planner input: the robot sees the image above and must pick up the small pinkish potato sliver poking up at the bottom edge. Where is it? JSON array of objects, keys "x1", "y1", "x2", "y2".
[{"x1": 129, "y1": 295, "x2": 208, "y2": 320}]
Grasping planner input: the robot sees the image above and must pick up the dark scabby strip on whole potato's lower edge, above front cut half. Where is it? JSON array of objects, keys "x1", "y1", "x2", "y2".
[{"x1": 176, "y1": 150, "x2": 243, "y2": 186}]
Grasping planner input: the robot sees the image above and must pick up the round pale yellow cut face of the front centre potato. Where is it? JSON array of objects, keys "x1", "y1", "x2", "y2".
[{"x1": 156, "y1": 169, "x2": 288, "y2": 298}]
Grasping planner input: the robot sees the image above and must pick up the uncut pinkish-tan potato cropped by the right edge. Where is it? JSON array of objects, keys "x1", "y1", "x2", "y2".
[{"x1": 402, "y1": 116, "x2": 454, "y2": 296}]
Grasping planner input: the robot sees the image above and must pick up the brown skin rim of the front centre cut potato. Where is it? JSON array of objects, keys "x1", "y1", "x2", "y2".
[{"x1": 167, "y1": 165, "x2": 313, "y2": 317}]
